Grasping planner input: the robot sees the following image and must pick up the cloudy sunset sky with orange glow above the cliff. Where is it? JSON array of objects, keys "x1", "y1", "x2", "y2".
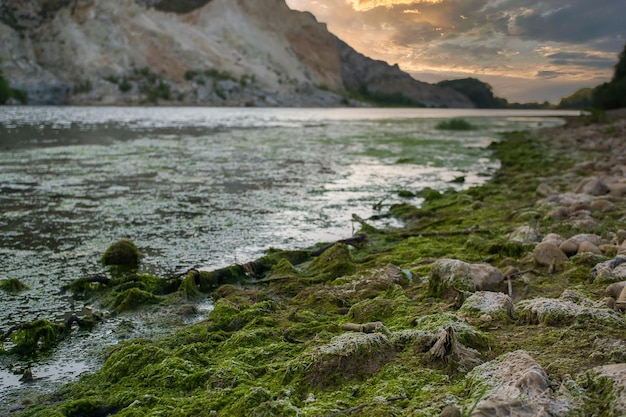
[{"x1": 286, "y1": 0, "x2": 626, "y2": 103}]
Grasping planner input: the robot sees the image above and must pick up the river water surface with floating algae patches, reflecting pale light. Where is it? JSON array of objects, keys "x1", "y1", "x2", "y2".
[{"x1": 0, "y1": 107, "x2": 572, "y2": 410}]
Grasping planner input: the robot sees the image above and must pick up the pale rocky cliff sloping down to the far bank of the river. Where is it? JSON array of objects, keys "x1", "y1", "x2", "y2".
[{"x1": 0, "y1": 0, "x2": 472, "y2": 107}]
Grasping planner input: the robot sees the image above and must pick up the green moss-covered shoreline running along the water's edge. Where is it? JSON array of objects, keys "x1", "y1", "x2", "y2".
[{"x1": 12, "y1": 112, "x2": 626, "y2": 417}]
